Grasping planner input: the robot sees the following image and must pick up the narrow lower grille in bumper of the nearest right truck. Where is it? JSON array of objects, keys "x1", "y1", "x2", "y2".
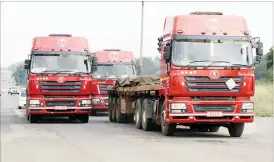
[{"x1": 193, "y1": 104, "x2": 235, "y2": 112}]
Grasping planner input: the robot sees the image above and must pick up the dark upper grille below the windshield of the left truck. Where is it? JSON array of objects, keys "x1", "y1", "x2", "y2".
[{"x1": 39, "y1": 81, "x2": 82, "y2": 92}]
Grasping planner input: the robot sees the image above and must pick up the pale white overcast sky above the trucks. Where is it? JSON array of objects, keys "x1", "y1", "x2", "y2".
[{"x1": 1, "y1": 2, "x2": 273, "y2": 66}]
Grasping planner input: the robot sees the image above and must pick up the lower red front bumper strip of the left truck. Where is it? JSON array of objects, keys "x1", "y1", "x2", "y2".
[{"x1": 28, "y1": 106, "x2": 91, "y2": 115}]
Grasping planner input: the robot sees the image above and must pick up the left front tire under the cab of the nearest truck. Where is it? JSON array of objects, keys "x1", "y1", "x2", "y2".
[{"x1": 161, "y1": 101, "x2": 176, "y2": 136}]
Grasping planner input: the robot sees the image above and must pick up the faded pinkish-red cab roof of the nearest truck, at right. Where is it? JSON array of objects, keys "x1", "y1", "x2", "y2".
[{"x1": 164, "y1": 11, "x2": 250, "y2": 37}]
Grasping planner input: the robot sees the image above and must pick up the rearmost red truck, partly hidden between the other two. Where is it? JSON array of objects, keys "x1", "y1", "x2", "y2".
[{"x1": 91, "y1": 49, "x2": 137, "y2": 116}]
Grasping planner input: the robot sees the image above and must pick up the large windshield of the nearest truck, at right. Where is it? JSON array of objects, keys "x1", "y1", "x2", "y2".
[{"x1": 172, "y1": 40, "x2": 253, "y2": 66}]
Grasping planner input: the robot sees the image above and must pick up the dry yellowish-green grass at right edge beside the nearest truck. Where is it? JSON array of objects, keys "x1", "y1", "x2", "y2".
[{"x1": 254, "y1": 81, "x2": 273, "y2": 117}]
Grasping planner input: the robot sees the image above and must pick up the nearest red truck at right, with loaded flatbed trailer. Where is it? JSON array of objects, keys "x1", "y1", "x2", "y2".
[{"x1": 106, "y1": 12, "x2": 263, "y2": 137}]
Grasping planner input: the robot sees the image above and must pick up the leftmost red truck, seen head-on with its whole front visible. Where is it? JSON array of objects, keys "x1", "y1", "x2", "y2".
[{"x1": 25, "y1": 34, "x2": 96, "y2": 123}]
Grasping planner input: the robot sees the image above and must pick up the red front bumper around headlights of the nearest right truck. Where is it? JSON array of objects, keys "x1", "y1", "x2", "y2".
[{"x1": 166, "y1": 100, "x2": 254, "y2": 124}]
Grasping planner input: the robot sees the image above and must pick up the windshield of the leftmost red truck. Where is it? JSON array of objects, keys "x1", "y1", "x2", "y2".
[{"x1": 31, "y1": 54, "x2": 91, "y2": 73}]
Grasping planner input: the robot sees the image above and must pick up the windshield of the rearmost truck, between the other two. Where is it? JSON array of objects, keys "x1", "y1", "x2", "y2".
[{"x1": 92, "y1": 64, "x2": 135, "y2": 78}]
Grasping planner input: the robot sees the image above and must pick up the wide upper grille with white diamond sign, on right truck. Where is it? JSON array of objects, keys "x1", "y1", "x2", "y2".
[{"x1": 185, "y1": 76, "x2": 243, "y2": 92}]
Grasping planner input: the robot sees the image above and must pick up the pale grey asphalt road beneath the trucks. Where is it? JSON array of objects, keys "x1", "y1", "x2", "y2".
[{"x1": 1, "y1": 89, "x2": 273, "y2": 162}]
